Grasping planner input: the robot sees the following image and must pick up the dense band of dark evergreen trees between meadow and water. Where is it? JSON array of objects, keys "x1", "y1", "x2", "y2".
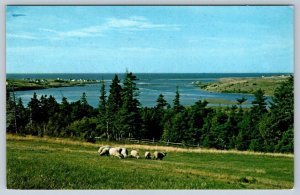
[{"x1": 6, "y1": 72, "x2": 294, "y2": 153}]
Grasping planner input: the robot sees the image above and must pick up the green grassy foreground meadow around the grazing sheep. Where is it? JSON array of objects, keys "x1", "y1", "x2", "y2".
[{"x1": 7, "y1": 135, "x2": 294, "y2": 189}]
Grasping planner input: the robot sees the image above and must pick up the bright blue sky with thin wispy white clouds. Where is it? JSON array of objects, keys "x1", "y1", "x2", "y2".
[{"x1": 6, "y1": 6, "x2": 294, "y2": 73}]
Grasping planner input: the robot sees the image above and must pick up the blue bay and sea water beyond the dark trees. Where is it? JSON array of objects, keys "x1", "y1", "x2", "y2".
[{"x1": 7, "y1": 73, "x2": 282, "y2": 107}]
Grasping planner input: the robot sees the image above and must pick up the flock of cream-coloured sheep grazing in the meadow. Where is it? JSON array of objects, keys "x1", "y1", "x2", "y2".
[{"x1": 98, "y1": 146, "x2": 167, "y2": 160}]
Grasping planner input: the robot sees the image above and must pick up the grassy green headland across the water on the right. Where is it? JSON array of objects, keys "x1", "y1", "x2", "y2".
[{"x1": 198, "y1": 76, "x2": 288, "y2": 96}]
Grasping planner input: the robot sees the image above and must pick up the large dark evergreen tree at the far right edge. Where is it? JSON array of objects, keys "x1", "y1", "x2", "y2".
[{"x1": 259, "y1": 76, "x2": 294, "y2": 152}]
